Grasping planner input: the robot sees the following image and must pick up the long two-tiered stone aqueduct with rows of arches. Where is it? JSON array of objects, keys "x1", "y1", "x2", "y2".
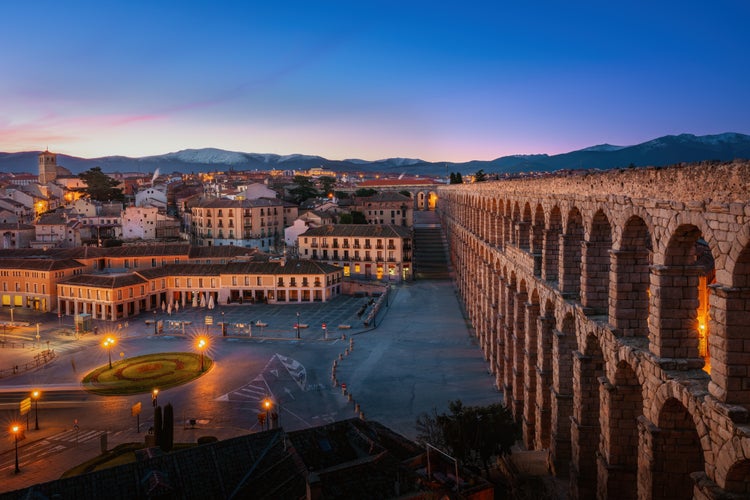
[{"x1": 438, "y1": 162, "x2": 750, "y2": 499}]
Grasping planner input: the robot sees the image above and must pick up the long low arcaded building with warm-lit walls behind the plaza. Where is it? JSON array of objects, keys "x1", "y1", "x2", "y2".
[{"x1": 57, "y1": 260, "x2": 343, "y2": 321}]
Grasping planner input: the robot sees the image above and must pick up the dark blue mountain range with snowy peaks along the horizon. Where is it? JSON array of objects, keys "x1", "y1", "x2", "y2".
[{"x1": 0, "y1": 132, "x2": 750, "y2": 175}]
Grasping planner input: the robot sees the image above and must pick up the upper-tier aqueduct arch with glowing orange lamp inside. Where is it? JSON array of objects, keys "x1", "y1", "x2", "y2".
[{"x1": 649, "y1": 224, "x2": 715, "y2": 368}]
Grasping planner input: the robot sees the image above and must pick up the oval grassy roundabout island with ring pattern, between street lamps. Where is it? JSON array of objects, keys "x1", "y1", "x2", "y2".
[{"x1": 81, "y1": 352, "x2": 213, "y2": 396}]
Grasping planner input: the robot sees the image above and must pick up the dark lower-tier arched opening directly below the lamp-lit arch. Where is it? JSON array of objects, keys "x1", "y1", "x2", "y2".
[{"x1": 651, "y1": 398, "x2": 704, "y2": 500}]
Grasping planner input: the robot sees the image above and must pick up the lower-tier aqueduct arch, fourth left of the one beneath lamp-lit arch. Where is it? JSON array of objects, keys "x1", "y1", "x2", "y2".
[{"x1": 534, "y1": 299, "x2": 557, "y2": 449}]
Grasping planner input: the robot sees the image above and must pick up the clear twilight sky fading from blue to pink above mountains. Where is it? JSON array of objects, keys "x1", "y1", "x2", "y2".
[{"x1": 0, "y1": 0, "x2": 750, "y2": 162}]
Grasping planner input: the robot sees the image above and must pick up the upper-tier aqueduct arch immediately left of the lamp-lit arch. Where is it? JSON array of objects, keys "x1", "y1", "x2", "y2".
[{"x1": 609, "y1": 215, "x2": 653, "y2": 337}]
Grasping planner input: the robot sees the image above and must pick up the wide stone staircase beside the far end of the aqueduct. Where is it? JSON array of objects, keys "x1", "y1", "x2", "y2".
[{"x1": 414, "y1": 211, "x2": 451, "y2": 280}]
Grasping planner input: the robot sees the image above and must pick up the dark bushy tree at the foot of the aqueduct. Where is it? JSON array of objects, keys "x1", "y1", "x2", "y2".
[{"x1": 416, "y1": 399, "x2": 520, "y2": 477}]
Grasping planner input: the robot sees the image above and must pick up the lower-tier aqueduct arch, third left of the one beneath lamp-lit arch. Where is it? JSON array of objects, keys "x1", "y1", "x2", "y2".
[{"x1": 551, "y1": 313, "x2": 576, "y2": 476}]
